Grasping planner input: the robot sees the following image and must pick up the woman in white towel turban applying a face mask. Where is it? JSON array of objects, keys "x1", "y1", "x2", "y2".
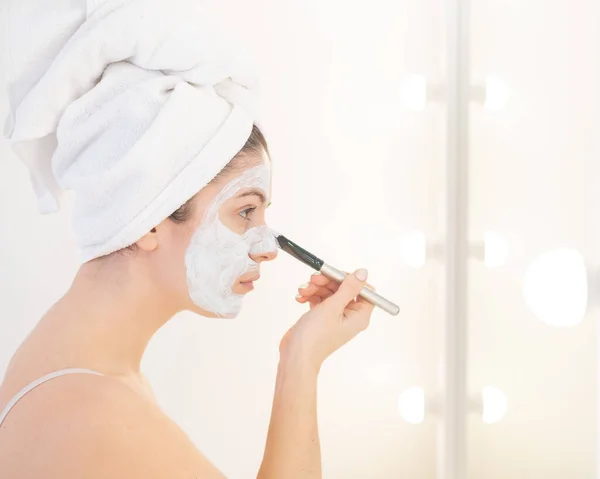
[{"x1": 0, "y1": 0, "x2": 373, "y2": 479}]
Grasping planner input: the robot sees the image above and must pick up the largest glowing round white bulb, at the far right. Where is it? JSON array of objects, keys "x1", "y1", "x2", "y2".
[{"x1": 523, "y1": 248, "x2": 588, "y2": 328}]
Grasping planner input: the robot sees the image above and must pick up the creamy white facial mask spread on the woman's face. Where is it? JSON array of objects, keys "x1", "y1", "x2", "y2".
[{"x1": 185, "y1": 164, "x2": 277, "y2": 318}]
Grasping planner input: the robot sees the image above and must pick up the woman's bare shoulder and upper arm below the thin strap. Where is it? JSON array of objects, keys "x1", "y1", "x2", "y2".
[{"x1": 0, "y1": 374, "x2": 223, "y2": 479}]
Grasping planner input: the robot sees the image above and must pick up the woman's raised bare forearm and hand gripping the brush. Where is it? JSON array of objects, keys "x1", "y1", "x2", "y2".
[{"x1": 258, "y1": 270, "x2": 373, "y2": 479}]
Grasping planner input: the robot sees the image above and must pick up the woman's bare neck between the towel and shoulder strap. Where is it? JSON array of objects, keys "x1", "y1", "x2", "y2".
[{"x1": 36, "y1": 259, "x2": 177, "y2": 376}]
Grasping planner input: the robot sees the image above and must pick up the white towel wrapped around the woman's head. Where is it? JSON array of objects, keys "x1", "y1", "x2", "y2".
[{"x1": 5, "y1": 0, "x2": 257, "y2": 262}]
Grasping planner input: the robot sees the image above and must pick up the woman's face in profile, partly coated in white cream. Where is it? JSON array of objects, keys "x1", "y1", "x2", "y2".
[{"x1": 155, "y1": 154, "x2": 277, "y2": 317}]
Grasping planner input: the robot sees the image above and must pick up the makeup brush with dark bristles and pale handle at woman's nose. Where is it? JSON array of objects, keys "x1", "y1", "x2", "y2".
[{"x1": 271, "y1": 230, "x2": 400, "y2": 316}]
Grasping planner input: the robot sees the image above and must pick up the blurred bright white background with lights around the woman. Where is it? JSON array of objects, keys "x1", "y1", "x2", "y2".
[{"x1": 0, "y1": 0, "x2": 600, "y2": 479}]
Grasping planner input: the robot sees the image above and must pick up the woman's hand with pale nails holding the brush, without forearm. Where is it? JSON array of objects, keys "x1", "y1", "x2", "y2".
[{"x1": 279, "y1": 269, "x2": 374, "y2": 371}]
